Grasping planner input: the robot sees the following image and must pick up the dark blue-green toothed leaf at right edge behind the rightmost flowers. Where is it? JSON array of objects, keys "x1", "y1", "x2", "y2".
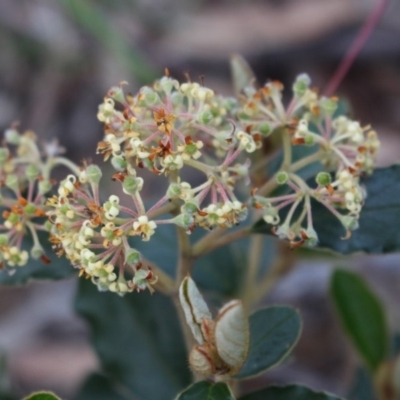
[{"x1": 253, "y1": 165, "x2": 400, "y2": 254}]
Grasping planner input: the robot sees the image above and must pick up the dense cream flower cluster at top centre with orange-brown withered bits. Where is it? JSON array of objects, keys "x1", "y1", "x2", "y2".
[{"x1": 97, "y1": 76, "x2": 253, "y2": 232}]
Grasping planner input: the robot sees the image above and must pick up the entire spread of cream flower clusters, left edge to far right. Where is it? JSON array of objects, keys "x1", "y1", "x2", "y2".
[{"x1": 0, "y1": 69, "x2": 379, "y2": 295}]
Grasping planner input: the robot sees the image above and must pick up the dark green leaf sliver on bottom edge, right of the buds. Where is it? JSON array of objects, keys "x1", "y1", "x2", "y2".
[{"x1": 239, "y1": 385, "x2": 343, "y2": 400}]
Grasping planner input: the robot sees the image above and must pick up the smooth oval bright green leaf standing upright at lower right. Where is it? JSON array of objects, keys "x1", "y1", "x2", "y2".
[{"x1": 330, "y1": 269, "x2": 389, "y2": 371}]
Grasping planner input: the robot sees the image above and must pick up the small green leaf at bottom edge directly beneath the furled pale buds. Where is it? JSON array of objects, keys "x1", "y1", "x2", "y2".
[{"x1": 176, "y1": 381, "x2": 235, "y2": 400}]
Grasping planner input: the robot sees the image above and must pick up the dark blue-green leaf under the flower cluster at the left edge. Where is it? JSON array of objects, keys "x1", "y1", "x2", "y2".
[{"x1": 0, "y1": 232, "x2": 77, "y2": 286}]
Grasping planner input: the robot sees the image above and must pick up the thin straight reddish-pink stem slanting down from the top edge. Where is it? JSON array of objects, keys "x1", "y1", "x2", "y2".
[{"x1": 324, "y1": 0, "x2": 389, "y2": 96}]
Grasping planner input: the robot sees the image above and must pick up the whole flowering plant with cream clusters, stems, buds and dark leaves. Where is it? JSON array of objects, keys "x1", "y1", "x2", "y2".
[{"x1": 0, "y1": 57, "x2": 399, "y2": 400}]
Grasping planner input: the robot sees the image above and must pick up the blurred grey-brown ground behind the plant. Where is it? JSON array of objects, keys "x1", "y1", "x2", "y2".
[{"x1": 0, "y1": 0, "x2": 400, "y2": 400}]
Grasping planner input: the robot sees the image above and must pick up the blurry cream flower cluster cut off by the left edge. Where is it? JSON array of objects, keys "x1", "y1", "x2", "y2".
[{"x1": 0, "y1": 126, "x2": 66, "y2": 273}]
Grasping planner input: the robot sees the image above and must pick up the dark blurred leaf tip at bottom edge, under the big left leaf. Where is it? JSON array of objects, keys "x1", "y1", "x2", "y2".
[{"x1": 74, "y1": 373, "x2": 133, "y2": 400}]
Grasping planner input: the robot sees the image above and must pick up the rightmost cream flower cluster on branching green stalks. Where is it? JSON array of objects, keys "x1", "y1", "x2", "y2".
[{"x1": 239, "y1": 74, "x2": 380, "y2": 246}]
